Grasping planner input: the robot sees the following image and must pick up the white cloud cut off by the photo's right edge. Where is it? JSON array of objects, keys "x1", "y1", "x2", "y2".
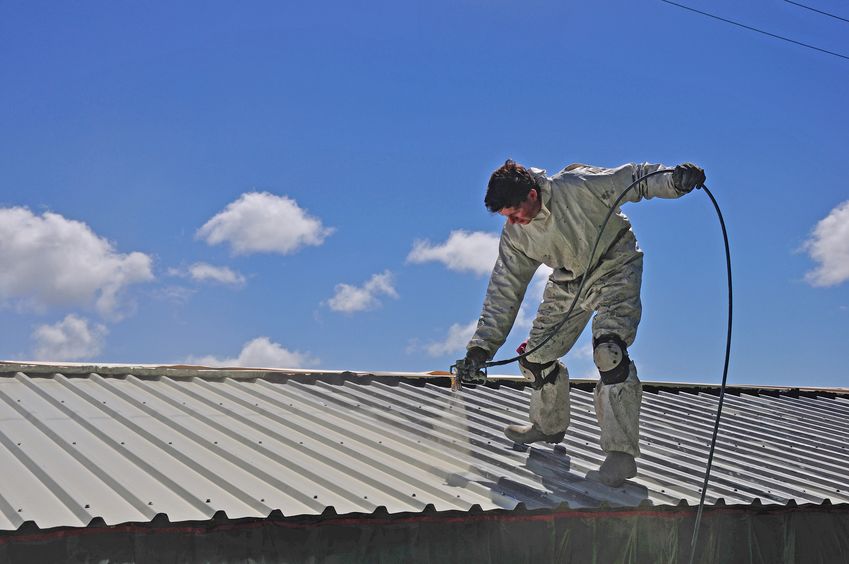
[{"x1": 803, "y1": 200, "x2": 849, "y2": 286}]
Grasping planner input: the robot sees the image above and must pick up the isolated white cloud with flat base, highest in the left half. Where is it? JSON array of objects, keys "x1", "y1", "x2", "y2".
[{"x1": 196, "y1": 192, "x2": 333, "y2": 255}]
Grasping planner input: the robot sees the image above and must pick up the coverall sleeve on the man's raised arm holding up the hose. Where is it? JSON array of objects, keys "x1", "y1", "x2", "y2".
[{"x1": 589, "y1": 163, "x2": 686, "y2": 206}]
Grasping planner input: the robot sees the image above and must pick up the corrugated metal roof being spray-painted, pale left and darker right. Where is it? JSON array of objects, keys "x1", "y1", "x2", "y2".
[{"x1": 0, "y1": 367, "x2": 849, "y2": 530}]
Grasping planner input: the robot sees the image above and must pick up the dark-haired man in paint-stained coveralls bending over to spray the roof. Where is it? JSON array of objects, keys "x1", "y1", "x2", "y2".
[{"x1": 466, "y1": 160, "x2": 705, "y2": 487}]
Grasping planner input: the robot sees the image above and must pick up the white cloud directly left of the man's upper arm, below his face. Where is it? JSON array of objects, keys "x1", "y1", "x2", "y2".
[{"x1": 407, "y1": 229, "x2": 499, "y2": 275}]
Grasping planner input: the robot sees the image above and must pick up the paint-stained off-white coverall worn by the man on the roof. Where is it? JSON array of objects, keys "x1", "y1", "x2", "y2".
[{"x1": 468, "y1": 164, "x2": 684, "y2": 457}]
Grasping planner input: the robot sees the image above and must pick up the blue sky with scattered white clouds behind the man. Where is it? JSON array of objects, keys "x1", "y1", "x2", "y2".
[{"x1": 0, "y1": 0, "x2": 849, "y2": 386}]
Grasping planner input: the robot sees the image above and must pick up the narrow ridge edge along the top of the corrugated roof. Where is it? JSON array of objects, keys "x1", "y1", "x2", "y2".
[{"x1": 0, "y1": 360, "x2": 849, "y2": 397}]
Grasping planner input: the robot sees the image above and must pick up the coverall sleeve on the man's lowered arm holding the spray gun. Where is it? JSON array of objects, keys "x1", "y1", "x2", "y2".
[{"x1": 467, "y1": 233, "x2": 541, "y2": 355}]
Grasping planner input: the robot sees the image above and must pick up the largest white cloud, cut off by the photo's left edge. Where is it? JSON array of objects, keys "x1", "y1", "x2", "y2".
[{"x1": 0, "y1": 207, "x2": 153, "y2": 317}]
